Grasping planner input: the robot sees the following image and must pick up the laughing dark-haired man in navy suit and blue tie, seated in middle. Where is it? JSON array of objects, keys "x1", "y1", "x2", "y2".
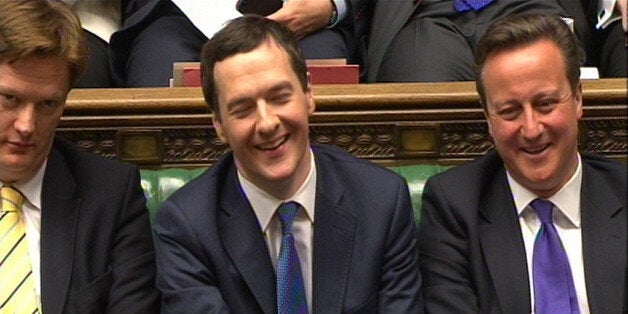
[{"x1": 155, "y1": 16, "x2": 422, "y2": 313}]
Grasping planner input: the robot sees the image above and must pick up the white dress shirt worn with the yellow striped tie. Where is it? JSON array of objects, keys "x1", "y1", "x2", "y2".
[{"x1": 0, "y1": 162, "x2": 46, "y2": 304}]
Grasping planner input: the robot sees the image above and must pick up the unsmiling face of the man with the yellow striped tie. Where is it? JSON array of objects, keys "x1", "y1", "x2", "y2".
[{"x1": 0, "y1": 55, "x2": 70, "y2": 183}]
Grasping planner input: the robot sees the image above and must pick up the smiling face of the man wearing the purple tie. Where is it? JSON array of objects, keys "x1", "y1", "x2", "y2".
[{"x1": 481, "y1": 40, "x2": 582, "y2": 197}]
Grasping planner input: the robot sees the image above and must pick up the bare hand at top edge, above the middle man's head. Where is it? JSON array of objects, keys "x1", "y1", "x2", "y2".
[{"x1": 267, "y1": 0, "x2": 334, "y2": 39}]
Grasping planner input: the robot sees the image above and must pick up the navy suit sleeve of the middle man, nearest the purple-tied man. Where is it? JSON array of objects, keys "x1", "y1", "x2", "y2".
[{"x1": 379, "y1": 177, "x2": 423, "y2": 313}]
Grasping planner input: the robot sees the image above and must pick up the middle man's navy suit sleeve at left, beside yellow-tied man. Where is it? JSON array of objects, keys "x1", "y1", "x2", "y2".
[{"x1": 155, "y1": 200, "x2": 230, "y2": 313}]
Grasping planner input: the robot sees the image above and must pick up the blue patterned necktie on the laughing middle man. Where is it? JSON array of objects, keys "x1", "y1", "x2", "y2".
[{"x1": 277, "y1": 202, "x2": 307, "y2": 314}]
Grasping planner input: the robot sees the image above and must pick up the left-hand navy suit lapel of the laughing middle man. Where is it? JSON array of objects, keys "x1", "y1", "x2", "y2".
[{"x1": 218, "y1": 168, "x2": 277, "y2": 313}]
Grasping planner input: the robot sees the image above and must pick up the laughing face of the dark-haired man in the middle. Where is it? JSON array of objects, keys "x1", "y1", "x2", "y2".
[{"x1": 214, "y1": 41, "x2": 314, "y2": 198}]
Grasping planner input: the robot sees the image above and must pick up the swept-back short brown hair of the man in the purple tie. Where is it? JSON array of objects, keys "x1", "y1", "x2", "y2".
[{"x1": 475, "y1": 14, "x2": 583, "y2": 111}]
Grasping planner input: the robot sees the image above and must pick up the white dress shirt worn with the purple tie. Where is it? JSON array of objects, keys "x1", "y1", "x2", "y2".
[{"x1": 507, "y1": 155, "x2": 590, "y2": 314}]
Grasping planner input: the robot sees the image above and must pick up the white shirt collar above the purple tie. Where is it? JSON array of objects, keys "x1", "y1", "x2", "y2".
[{"x1": 506, "y1": 154, "x2": 582, "y2": 228}]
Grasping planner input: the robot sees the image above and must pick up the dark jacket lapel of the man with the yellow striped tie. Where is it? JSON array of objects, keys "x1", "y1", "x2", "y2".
[{"x1": 40, "y1": 148, "x2": 80, "y2": 313}]
